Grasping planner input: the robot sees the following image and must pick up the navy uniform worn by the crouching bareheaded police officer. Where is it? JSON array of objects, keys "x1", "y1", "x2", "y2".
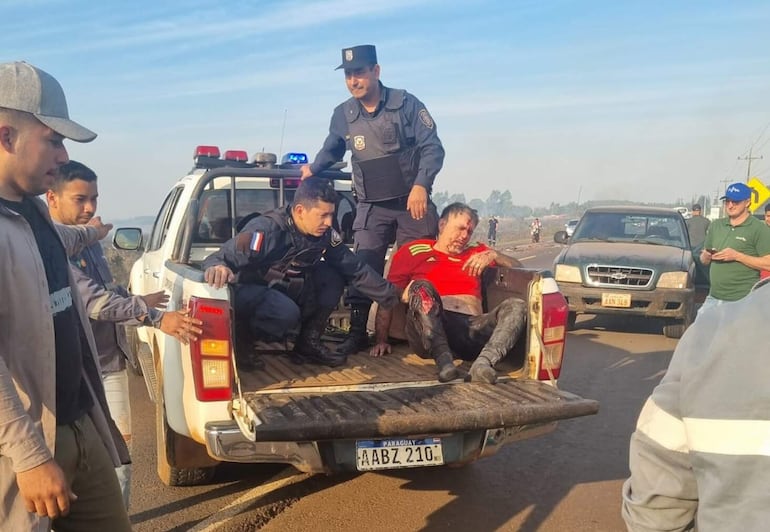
[{"x1": 203, "y1": 207, "x2": 398, "y2": 365}]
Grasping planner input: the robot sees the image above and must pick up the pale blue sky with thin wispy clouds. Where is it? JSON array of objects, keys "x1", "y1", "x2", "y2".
[{"x1": 0, "y1": 0, "x2": 770, "y2": 219}]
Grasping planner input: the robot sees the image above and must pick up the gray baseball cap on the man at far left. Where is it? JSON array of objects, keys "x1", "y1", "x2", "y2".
[{"x1": 0, "y1": 61, "x2": 96, "y2": 142}]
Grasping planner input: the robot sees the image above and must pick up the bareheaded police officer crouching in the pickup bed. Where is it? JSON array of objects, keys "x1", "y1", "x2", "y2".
[{"x1": 204, "y1": 177, "x2": 398, "y2": 369}]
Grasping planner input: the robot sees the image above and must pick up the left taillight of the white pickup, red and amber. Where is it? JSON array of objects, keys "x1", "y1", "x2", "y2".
[{"x1": 189, "y1": 296, "x2": 233, "y2": 401}]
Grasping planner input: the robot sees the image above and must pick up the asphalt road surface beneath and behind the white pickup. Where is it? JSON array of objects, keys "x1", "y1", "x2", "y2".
[{"x1": 124, "y1": 243, "x2": 676, "y2": 532}]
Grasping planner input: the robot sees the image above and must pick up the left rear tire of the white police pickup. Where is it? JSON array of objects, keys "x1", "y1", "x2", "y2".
[{"x1": 155, "y1": 380, "x2": 219, "y2": 486}]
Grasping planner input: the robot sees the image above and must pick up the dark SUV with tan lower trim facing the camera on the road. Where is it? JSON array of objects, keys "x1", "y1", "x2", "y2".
[{"x1": 554, "y1": 206, "x2": 695, "y2": 338}]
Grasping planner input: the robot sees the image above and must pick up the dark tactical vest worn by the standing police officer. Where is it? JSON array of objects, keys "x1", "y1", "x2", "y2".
[{"x1": 344, "y1": 87, "x2": 420, "y2": 202}]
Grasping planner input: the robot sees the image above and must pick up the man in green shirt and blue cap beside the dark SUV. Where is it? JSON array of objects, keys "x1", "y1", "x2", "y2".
[{"x1": 699, "y1": 183, "x2": 770, "y2": 312}]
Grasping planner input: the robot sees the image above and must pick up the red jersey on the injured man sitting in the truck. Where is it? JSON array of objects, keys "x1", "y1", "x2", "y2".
[{"x1": 388, "y1": 240, "x2": 494, "y2": 299}]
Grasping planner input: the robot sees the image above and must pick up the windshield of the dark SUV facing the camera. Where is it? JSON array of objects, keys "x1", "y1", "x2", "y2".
[{"x1": 572, "y1": 212, "x2": 687, "y2": 249}]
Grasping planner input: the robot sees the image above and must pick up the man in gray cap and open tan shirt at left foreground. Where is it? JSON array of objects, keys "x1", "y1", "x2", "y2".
[{"x1": 0, "y1": 62, "x2": 131, "y2": 532}]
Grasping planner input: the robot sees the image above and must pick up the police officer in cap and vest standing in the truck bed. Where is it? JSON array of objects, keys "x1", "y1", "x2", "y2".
[{"x1": 302, "y1": 44, "x2": 444, "y2": 354}]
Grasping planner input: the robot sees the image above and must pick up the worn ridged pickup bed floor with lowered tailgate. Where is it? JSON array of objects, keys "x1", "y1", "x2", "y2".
[{"x1": 240, "y1": 344, "x2": 597, "y2": 441}]
